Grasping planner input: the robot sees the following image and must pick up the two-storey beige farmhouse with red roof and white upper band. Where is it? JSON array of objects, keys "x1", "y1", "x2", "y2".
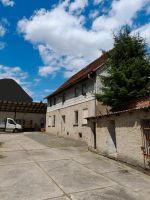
[{"x1": 46, "y1": 54, "x2": 106, "y2": 142}]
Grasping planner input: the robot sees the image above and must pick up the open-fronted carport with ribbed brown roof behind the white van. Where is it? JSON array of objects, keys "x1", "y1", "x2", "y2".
[{"x1": 0, "y1": 100, "x2": 47, "y2": 130}]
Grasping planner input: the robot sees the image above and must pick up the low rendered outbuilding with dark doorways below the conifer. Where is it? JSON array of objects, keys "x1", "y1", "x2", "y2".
[{"x1": 88, "y1": 98, "x2": 150, "y2": 169}]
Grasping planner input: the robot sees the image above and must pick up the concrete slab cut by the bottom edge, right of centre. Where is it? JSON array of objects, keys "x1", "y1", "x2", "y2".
[{"x1": 71, "y1": 186, "x2": 146, "y2": 200}]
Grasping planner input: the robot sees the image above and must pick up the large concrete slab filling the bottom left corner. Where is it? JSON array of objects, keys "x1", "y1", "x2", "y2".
[{"x1": 0, "y1": 163, "x2": 63, "y2": 200}]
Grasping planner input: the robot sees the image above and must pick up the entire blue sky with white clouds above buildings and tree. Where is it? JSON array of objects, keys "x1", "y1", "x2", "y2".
[{"x1": 0, "y1": 0, "x2": 150, "y2": 101}]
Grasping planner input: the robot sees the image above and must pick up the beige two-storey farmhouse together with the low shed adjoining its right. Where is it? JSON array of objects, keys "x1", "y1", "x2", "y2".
[{"x1": 46, "y1": 54, "x2": 150, "y2": 168}]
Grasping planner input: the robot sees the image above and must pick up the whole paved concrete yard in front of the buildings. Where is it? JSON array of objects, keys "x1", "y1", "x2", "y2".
[{"x1": 0, "y1": 133, "x2": 150, "y2": 200}]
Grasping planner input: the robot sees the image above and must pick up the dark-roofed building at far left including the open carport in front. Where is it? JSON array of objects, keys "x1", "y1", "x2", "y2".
[{"x1": 0, "y1": 79, "x2": 47, "y2": 131}]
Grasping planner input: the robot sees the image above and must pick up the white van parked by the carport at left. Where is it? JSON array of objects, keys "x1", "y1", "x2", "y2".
[{"x1": 0, "y1": 118, "x2": 22, "y2": 132}]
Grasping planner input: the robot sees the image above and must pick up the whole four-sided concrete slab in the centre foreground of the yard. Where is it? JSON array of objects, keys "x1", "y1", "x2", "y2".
[{"x1": 39, "y1": 160, "x2": 115, "y2": 193}]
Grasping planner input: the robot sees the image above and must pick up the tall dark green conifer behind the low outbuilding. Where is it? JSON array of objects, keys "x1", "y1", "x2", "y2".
[{"x1": 96, "y1": 27, "x2": 150, "y2": 108}]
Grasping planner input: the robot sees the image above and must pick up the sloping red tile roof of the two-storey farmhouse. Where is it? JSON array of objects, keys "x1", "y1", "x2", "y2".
[{"x1": 46, "y1": 53, "x2": 107, "y2": 98}]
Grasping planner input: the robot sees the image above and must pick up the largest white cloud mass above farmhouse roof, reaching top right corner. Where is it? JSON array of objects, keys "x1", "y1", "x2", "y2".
[{"x1": 18, "y1": 0, "x2": 149, "y2": 77}]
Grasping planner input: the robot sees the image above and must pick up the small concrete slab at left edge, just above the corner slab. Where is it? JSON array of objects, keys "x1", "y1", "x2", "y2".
[{"x1": 0, "y1": 151, "x2": 33, "y2": 165}]
